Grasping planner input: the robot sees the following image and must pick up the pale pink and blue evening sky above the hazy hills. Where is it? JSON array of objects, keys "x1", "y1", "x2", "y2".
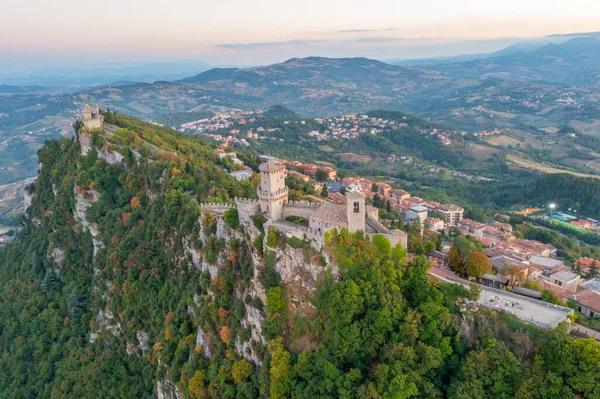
[{"x1": 0, "y1": 0, "x2": 600, "y2": 72}]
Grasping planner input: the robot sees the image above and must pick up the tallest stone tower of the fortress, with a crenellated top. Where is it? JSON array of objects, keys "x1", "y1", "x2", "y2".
[{"x1": 256, "y1": 162, "x2": 288, "y2": 221}]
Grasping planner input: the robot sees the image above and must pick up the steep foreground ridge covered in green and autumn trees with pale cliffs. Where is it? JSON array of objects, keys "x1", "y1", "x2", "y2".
[{"x1": 0, "y1": 114, "x2": 600, "y2": 399}]
